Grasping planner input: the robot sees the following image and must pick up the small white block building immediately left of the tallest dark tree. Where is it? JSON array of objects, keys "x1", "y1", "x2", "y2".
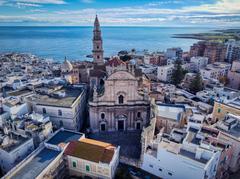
[{"x1": 157, "y1": 64, "x2": 174, "y2": 82}]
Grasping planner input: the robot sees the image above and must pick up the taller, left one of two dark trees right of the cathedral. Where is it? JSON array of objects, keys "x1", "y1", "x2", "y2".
[{"x1": 172, "y1": 60, "x2": 184, "y2": 85}]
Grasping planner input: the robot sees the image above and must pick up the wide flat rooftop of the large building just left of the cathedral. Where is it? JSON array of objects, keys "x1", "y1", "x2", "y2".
[{"x1": 27, "y1": 88, "x2": 83, "y2": 107}]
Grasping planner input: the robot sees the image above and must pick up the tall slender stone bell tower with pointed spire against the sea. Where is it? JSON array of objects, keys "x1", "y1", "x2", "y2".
[{"x1": 92, "y1": 15, "x2": 104, "y2": 65}]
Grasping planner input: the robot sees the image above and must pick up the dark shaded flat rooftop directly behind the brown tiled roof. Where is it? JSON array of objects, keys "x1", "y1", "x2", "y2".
[{"x1": 46, "y1": 130, "x2": 83, "y2": 145}]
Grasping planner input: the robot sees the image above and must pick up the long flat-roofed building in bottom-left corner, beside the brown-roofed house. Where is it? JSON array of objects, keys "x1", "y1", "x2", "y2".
[{"x1": 3, "y1": 129, "x2": 85, "y2": 179}]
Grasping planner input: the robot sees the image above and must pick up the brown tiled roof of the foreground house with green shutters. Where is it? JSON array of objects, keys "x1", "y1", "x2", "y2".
[{"x1": 64, "y1": 139, "x2": 115, "y2": 164}]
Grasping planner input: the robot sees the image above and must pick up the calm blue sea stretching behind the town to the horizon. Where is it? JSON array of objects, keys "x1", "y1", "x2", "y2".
[{"x1": 0, "y1": 26, "x2": 216, "y2": 61}]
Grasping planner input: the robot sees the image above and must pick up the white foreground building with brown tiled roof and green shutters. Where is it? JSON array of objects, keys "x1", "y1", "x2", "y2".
[{"x1": 64, "y1": 138, "x2": 120, "y2": 179}]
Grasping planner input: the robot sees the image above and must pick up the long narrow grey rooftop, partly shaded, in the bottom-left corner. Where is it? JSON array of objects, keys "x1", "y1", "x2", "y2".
[{"x1": 11, "y1": 148, "x2": 61, "y2": 179}]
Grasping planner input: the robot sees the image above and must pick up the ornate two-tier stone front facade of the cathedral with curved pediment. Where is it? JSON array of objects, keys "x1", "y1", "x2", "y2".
[{"x1": 89, "y1": 69, "x2": 149, "y2": 132}]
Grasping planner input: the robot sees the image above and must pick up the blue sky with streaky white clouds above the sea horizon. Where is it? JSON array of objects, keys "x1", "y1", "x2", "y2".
[{"x1": 0, "y1": 0, "x2": 240, "y2": 28}]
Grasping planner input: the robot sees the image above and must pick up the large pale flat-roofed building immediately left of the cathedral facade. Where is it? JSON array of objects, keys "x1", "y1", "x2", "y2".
[{"x1": 26, "y1": 86, "x2": 86, "y2": 131}]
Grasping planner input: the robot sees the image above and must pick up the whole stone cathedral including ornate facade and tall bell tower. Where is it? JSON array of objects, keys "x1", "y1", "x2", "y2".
[{"x1": 89, "y1": 16, "x2": 150, "y2": 132}]
